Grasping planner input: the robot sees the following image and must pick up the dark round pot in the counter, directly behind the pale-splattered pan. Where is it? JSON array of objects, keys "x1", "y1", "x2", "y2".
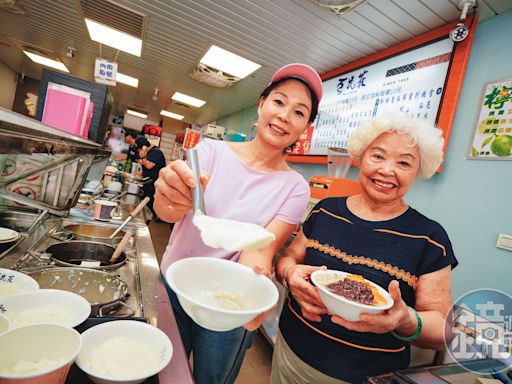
[{"x1": 45, "y1": 240, "x2": 126, "y2": 270}]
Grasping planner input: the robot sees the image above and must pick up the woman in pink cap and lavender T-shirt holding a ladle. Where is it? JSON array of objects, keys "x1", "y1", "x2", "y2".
[{"x1": 155, "y1": 64, "x2": 322, "y2": 384}]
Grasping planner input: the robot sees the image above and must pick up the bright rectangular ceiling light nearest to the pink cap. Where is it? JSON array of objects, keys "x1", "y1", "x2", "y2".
[{"x1": 200, "y1": 45, "x2": 261, "y2": 79}]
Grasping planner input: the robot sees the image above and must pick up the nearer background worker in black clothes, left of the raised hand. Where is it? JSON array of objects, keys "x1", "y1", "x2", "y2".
[{"x1": 135, "y1": 136, "x2": 165, "y2": 214}]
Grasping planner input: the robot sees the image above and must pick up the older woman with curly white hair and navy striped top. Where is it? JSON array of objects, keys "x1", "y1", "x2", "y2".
[{"x1": 271, "y1": 115, "x2": 457, "y2": 383}]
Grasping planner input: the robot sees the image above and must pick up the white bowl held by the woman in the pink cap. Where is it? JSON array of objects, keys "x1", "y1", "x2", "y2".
[{"x1": 166, "y1": 257, "x2": 279, "y2": 331}]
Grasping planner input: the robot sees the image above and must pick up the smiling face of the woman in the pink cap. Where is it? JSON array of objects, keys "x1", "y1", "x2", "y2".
[{"x1": 258, "y1": 79, "x2": 311, "y2": 149}]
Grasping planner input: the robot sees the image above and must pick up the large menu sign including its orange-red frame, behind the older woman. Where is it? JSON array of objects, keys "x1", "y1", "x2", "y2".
[{"x1": 287, "y1": 15, "x2": 478, "y2": 164}]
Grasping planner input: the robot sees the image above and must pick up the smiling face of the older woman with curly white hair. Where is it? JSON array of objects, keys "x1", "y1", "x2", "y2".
[{"x1": 359, "y1": 132, "x2": 420, "y2": 203}]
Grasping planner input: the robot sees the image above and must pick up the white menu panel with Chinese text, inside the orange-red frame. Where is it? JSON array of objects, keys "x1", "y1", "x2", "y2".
[{"x1": 298, "y1": 38, "x2": 454, "y2": 155}]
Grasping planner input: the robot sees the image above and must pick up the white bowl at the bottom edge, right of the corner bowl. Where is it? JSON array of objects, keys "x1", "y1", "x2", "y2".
[{"x1": 76, "y1": 320, "x2": 173, "y2": 384}]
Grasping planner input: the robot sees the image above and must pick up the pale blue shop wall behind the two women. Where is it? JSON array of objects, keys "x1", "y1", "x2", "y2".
[{"x1": 217, "y1": 12, "x2": 512, "y2": 298}]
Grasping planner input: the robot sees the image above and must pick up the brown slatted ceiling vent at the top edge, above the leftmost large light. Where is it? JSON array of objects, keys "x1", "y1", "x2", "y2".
[{"x1": 78, "y1": 0, "x2": 145, "y2": 40}]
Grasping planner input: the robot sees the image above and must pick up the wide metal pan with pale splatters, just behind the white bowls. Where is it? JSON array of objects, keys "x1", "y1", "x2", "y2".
[{"x1": 29, "y1": 268, "x2": 135, "y2": 317}]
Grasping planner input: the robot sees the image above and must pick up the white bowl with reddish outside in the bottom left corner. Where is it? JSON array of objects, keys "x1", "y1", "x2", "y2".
[{"x1": 0, "y1": 324, "x2": 81, "y2": 384}]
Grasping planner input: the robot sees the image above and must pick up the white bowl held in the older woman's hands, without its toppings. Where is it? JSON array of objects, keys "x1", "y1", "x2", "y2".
[{"x1": 311, "y1": 269, "x2": 393, "y2": 321}]
